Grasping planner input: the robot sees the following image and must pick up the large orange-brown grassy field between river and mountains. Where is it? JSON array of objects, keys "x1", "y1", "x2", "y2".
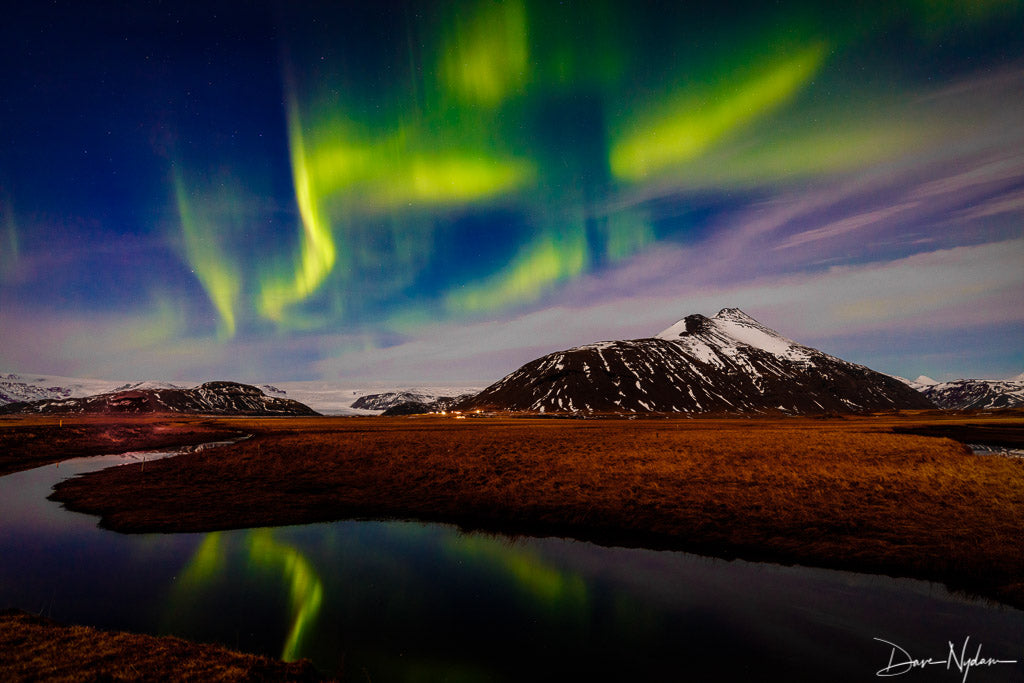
[{"x1": 32, "y1": 413, "x2": 1024, "y2": 606}]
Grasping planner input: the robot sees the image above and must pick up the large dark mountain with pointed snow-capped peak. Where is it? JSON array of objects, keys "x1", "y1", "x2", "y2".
[{"x1": 455, "y1": 308, "x2": 935, "y2": 414}]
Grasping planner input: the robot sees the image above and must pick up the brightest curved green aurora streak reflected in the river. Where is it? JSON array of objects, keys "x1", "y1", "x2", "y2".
[{"x1": 248, "y1": 528, "x2": 324, "y2": 661}]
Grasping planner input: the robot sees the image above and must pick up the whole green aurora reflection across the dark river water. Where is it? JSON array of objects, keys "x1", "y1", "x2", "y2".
[{"x1": 165, "y1": 522, "x2": 592, "y2": 661}]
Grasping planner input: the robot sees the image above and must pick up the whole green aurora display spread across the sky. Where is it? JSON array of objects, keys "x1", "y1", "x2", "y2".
[{"x1": 161, "y1": 0, "x2": 1020, "y2": 338}]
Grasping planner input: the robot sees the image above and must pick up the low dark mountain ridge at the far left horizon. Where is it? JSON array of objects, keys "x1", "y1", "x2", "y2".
[{"x1": 0, "y1": 382, "x2": 318, "y2": 416}]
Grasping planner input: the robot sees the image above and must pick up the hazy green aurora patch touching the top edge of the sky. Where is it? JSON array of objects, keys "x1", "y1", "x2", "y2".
[{"x1": 438, "y1": 0, "x2": 529, "y2": 106}]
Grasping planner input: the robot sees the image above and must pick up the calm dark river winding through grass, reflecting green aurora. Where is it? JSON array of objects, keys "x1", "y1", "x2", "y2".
[{"x1": 0, "y1": 454, "x2": 1024, "y2": 683}]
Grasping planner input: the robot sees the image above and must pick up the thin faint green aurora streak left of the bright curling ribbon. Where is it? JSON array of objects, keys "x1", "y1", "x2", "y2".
[{"x1": 173, "y1": 168, "x2": 241, "y2": 339}]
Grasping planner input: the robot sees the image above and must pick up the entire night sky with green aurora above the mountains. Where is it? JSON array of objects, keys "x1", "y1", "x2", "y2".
[{"x1": 0, "y1": 0, "x2": 1024, "y2": 385}]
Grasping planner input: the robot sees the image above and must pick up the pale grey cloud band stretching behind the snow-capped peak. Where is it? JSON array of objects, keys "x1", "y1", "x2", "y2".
[{"x1": 317, "y1": 240, "x2": 1024, "y2": 382}]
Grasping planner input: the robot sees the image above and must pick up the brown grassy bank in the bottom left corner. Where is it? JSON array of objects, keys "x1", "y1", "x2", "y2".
[{"x1": 0, "y1": 609, "x2": 321, "y2": 682}]
